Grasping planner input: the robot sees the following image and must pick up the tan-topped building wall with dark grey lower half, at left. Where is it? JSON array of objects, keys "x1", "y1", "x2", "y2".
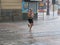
[{"x1": 0, "y1": 0, "x2": 22, "y2": 21}]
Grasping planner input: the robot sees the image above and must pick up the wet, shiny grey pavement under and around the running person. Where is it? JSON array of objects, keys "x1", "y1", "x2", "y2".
[{"x1": 0, "y1": 17, "x2": 60, "y2": 45}]
